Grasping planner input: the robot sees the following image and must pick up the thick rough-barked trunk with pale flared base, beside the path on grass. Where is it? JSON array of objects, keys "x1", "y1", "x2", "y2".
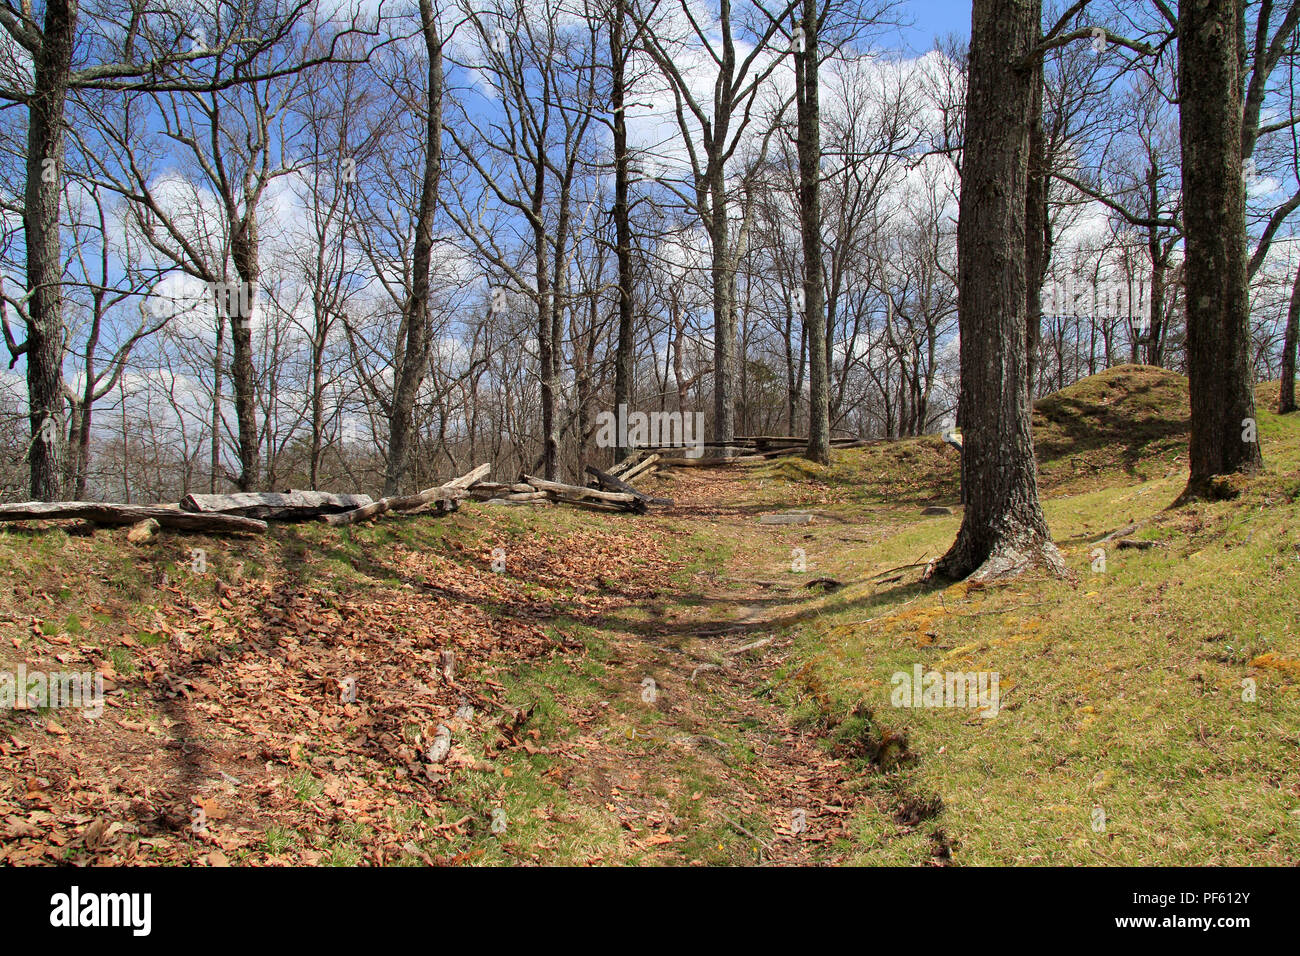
[{"x1": 936, "y1": 0, "x2": 1065, "y2": 580}]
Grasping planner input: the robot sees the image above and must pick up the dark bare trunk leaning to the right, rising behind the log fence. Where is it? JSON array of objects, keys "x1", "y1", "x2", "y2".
[{"x1": 384, "y1": 0, "x2": 442, "y2": 496}]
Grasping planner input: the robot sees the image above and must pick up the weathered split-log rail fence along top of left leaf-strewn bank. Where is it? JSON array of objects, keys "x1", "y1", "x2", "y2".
[{"x1": 0, "y1": 455, "x2": 672, "y2": 535}]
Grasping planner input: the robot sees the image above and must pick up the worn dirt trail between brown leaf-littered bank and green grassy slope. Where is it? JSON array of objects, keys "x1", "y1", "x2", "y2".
[{"x1": 543, "y1": 472, "x2": 889, "y2": 865}]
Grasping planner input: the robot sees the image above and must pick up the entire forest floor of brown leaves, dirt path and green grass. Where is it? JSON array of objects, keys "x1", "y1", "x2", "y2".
[{"x1": 0, "y1": 367, "x2": 1300, "y2": 865}]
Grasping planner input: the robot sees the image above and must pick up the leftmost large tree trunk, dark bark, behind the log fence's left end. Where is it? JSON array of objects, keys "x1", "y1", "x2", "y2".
[{"x1": 22, "y1": 0, "x2": 77, "y2": 501}]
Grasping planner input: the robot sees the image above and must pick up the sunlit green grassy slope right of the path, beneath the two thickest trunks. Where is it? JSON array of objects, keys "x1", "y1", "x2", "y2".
[{"x1": 722, "y1": 367, "x2": 1300, "y2": 864}]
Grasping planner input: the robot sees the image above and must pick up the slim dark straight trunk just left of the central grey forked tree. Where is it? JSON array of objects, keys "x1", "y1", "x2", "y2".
[{"x1": 610, "y1": 0, "x2": 636, "y2": 460}]
